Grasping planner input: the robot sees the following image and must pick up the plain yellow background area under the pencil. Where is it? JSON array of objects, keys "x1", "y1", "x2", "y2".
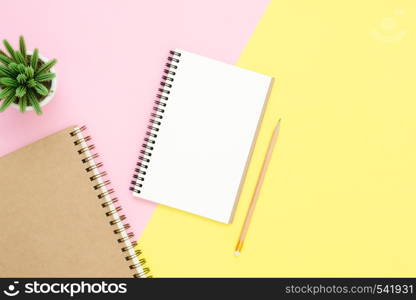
[{"x1": 142, "y1": 0, "x2": 416, "y2": 277}]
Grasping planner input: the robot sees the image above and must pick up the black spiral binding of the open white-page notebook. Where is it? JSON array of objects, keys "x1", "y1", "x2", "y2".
[{"x1": 130, "y1": 50, "x2": 182, "y2": 194}]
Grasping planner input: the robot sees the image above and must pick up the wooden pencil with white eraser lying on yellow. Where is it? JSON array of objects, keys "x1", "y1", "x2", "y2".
[{"x1": 234, "y1": 119, "x2": 280, "y2": 256}]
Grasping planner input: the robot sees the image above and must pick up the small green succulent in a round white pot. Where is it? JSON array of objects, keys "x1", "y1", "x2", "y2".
[{"x1": 0, "y1": 36, "x2": 57, "y2": 114}]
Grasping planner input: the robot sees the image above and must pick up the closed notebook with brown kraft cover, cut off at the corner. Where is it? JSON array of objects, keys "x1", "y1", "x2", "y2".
[{"x1": 0, "y1": 126, "x2": 149, "y2": 277}]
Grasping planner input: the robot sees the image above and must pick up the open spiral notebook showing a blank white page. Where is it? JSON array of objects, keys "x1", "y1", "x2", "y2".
[{"x1": 131, "y1": 49, "x2": 273, "y2": 223}]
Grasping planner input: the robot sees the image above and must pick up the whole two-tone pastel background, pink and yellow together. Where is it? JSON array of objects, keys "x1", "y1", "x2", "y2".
[{"x1": 4, "y1": 0, "x2": 416, "y2": 277}]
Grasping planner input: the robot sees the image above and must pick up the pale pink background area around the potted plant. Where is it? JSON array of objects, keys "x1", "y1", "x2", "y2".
[{"x1": 0, "y1": 0, "x2": 268, "y2": 235}]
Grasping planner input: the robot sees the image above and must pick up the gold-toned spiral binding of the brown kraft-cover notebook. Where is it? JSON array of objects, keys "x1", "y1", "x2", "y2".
[{"x1": 70, "y1": 126, "x2": 151, "y2": 278}]
